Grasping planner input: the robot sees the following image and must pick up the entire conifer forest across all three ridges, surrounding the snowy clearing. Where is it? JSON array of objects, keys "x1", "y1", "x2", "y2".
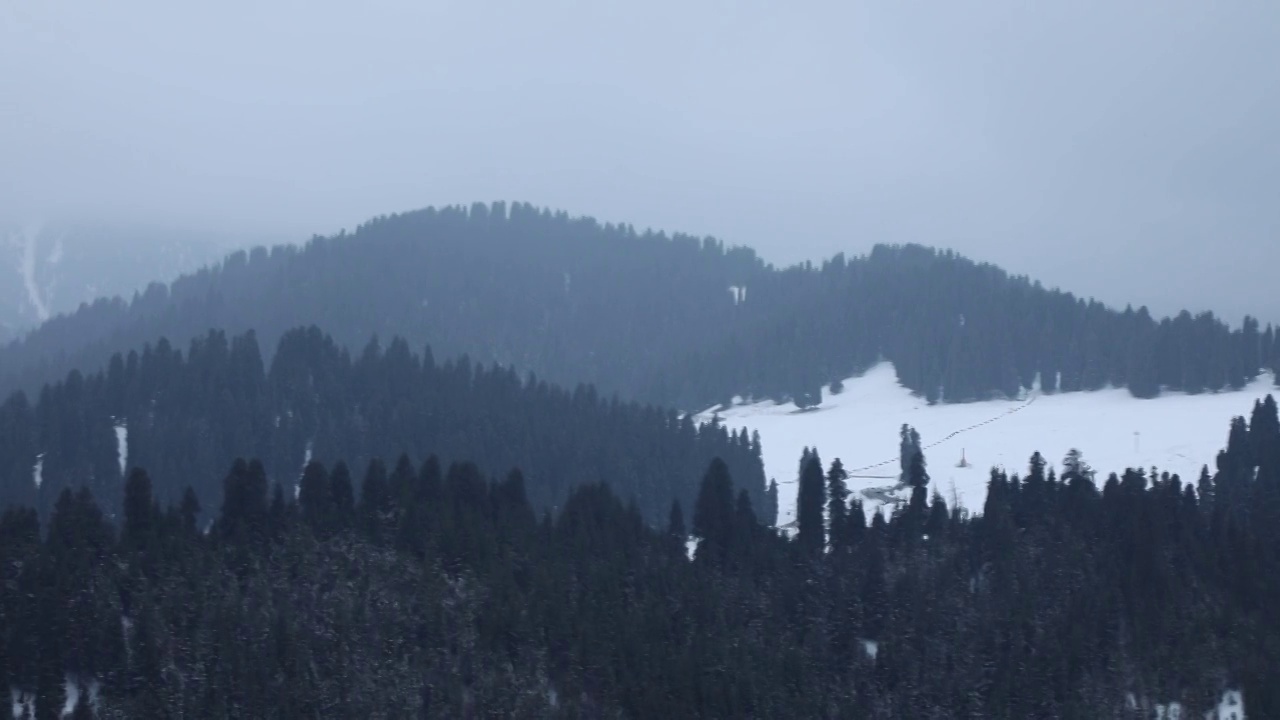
[{"x1": 0, "y1": 204, "x2": 1280, "y2": 720}]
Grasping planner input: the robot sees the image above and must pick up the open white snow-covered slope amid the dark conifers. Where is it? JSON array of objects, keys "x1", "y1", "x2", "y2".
[{"x1": 703, "y1": 363, "x2": 1275, "y2": 525}]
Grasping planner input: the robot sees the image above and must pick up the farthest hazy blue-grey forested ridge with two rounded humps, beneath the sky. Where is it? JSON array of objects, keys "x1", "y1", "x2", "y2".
[{"x1": 0, "y1": 204, "x2": 1280, "y2": 410}]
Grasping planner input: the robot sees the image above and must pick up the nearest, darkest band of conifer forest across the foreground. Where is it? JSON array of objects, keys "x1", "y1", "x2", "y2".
[{"x1": 0, "y1": 398, "x2": 1280, "y2": 720}]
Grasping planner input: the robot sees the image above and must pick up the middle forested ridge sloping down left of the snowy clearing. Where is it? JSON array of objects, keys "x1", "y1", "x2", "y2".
[{"x1": 0, "y1": 327, "x2": 773, "y2": 523}]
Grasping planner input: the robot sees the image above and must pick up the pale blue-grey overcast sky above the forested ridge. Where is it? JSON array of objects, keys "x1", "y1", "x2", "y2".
[{"x1": 0, "y1": 0, "x2": 1280, "y2": 320}]
